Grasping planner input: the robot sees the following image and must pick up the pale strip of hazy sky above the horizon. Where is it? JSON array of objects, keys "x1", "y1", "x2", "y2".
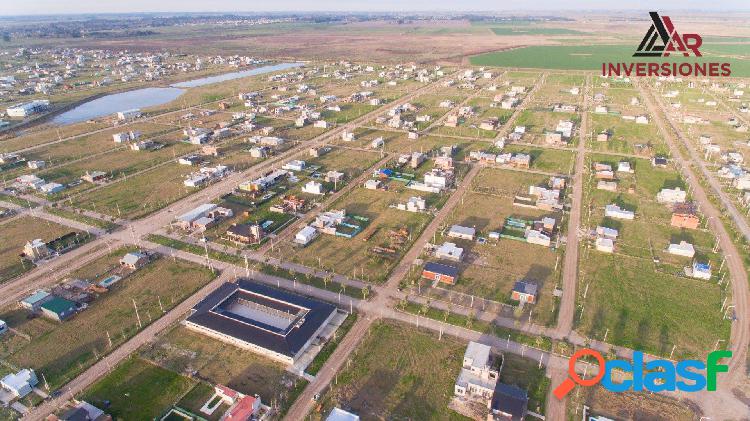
[{"x1": 0, "y1": 0, "x2": 750, "y2": 15}]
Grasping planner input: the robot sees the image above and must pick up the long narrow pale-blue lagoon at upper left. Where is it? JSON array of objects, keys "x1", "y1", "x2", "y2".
[{"x1": 52, "y1": 63, "x2": 302, "y2": 125}]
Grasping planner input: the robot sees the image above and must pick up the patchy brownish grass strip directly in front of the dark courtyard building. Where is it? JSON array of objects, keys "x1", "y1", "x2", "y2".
[{"x1": 140, "y1": 326, "x2": 306, "y2": 410}]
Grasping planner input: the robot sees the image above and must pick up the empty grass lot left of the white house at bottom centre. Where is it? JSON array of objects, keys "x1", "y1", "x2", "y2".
[{"x1": 312, "y1": 322, "x2": 466, "y2": 420}]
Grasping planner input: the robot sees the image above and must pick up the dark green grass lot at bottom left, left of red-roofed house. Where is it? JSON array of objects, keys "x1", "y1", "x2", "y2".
[{"x1": 81, "y1": 357, "x2": 196, "y2": 420}]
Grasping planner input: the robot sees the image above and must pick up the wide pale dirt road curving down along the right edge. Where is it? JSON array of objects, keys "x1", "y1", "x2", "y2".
[{"x1": 638, "y1": 84, "x2": 750, "y2": 419}]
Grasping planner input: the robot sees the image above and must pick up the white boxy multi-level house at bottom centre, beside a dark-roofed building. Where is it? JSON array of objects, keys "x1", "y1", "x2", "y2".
[{"x1": 453, "y1": 341, "x2": 500, "y2": 404}]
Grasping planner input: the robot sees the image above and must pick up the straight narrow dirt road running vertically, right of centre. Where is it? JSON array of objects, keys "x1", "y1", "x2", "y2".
[{"x1": 557, "y1": 76, "x2": 591, "y2": 336}]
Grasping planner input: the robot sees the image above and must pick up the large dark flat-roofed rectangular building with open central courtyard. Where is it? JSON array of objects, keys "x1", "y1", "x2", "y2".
[{"x1": 185, "y1": 279, "x2": 336, "y2": 364}]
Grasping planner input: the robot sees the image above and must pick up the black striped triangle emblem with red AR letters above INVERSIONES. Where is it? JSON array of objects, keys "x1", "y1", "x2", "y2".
[{"x1": 633, "y1": 12, "x2": 703, "y2": 57}]
